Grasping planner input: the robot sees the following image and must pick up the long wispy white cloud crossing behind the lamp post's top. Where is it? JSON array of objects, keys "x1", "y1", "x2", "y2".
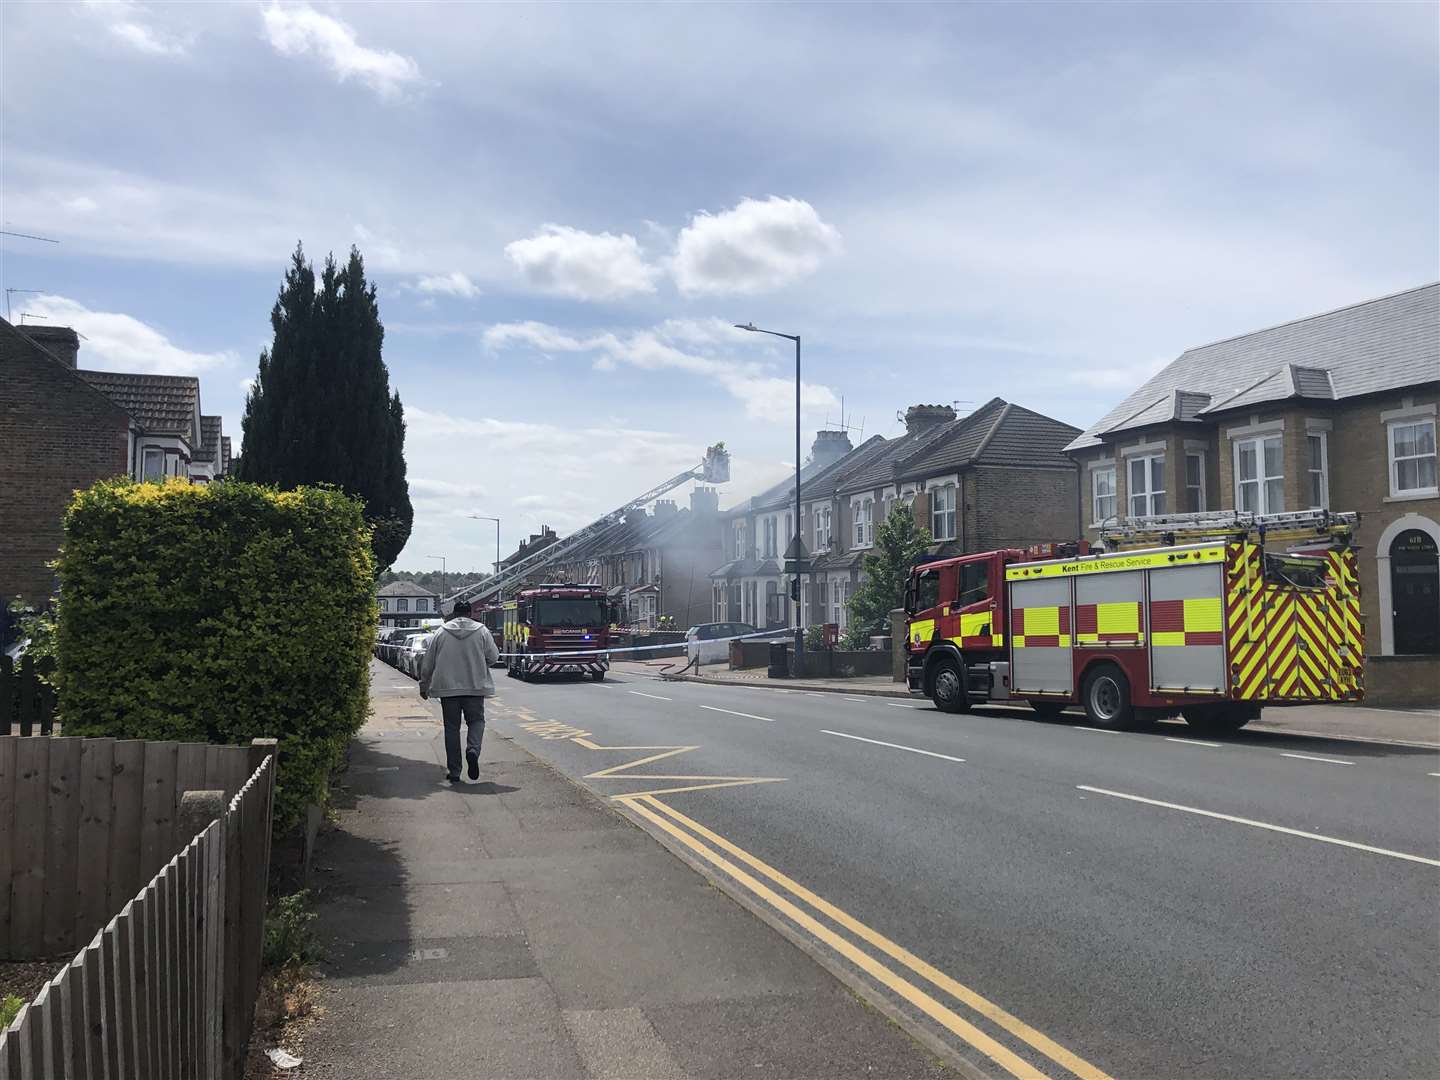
[{"x1": 484, "y1": 318, "x2": 840, "y2": 420}]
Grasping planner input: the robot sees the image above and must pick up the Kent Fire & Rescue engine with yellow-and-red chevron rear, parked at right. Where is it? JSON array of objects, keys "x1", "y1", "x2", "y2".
[{"x1": 906, "y1": 511, "x2": 1364, "y2": 732}]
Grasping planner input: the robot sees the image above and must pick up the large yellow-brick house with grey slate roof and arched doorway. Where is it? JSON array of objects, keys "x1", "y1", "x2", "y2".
[{"x1": 1066, "y1": 284, "x2": 1440, "y2": 704}]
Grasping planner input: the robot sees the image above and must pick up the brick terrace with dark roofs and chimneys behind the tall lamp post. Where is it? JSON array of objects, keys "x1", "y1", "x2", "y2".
[{"x1": 711, "y1": 408, "x2": 1080, "y2": 631}]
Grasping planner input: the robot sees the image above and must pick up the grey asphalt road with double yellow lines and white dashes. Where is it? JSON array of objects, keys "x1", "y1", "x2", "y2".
[{"x1": 475, "y1": 672, "x2": 1440, "y2": 1079}]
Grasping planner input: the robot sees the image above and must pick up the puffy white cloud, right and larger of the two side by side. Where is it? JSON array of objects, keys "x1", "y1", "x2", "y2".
[{"x1": 671, "y1": 196, "x2": 841, "y2": 297}]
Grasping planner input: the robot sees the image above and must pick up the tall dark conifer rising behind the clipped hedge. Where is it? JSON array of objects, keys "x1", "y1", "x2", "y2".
[{"x1": 236, "y1": 245, "x2": 415, "y2": 569}]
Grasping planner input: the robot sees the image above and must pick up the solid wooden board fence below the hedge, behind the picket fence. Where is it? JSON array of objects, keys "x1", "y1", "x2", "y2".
[{"x1": 0, "y1": 734, "x2": 270, "y2": 960}]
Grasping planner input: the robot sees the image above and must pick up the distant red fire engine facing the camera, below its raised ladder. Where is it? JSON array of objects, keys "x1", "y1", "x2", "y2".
[{"x1": 501, "y1": 585, "x2": 611, "y2": 683}]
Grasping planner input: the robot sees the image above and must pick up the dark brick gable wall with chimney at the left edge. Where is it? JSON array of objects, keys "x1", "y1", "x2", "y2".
[{"x1": 0, "y1": 320, "x2": 140, "y2": 616}]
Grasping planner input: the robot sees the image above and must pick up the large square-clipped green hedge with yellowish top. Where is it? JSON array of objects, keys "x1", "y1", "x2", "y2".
[{"x1": 55, "y1": 480, "x2": 376, "y2": 828}]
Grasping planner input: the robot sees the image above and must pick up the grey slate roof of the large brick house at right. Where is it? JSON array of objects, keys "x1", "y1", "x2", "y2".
[{"x1": 1066, "y1": 282, "x2": 1440, "y2": 451}]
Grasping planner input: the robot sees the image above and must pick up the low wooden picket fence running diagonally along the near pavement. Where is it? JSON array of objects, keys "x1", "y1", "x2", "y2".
[{"x1": 0, "y1": 744, "x2": 275, "y2": 1080}]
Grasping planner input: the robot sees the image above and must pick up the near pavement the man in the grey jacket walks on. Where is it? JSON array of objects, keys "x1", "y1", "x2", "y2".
[{"x1": 301, "y1": 664, "x2": 950, "y2": 1080}]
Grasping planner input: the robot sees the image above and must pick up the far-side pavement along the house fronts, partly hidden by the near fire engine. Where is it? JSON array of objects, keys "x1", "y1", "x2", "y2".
[{"x1": 613, "y1": 660, "x2": 1440, "y2": 747}]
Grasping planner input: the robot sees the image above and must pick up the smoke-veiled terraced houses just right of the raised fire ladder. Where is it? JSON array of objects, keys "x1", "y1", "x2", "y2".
[{"x1": 539, "y1": 485, "x2": 720, "y2": 629}]
